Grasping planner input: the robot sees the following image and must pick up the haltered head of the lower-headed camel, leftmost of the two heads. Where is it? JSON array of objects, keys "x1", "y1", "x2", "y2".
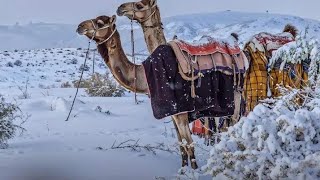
[{"x1": 77, "y1": 15, "x2": 116, "y2": 44}]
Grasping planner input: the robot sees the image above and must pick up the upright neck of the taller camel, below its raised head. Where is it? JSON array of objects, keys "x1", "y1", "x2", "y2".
[{"x1": 141, "y1": 7, "x2": 166, "y2": 53}]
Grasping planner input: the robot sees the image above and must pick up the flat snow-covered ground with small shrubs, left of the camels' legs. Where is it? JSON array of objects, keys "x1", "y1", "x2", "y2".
[{"x1": 0, "y1": 49, "x2": 210, "y2": 180}]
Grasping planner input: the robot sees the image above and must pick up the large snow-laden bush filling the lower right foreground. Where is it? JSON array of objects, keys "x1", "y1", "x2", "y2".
[{"x1": 203, "y1": 91, "x2": 320, "y2": 179}]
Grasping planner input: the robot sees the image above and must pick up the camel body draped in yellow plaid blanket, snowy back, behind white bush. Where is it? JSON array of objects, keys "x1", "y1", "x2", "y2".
[{"x1": 244, "y1": 24, "x2": 308, "y2": 114}]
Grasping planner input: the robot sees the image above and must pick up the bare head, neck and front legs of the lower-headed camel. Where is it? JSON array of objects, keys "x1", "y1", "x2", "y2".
[{"x1": 77, "y1": 16, "x2": 198, "y2": 169}]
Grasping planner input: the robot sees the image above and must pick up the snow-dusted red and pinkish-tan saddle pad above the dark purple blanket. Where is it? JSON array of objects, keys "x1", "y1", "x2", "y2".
[{"x1": 169, "y1": 40, "x2": 247, "y2": 75}]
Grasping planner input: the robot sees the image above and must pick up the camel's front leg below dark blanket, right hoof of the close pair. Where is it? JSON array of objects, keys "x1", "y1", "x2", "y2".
[{"x1": 173, "y1": 113, "x2": 198, "y2": 169}]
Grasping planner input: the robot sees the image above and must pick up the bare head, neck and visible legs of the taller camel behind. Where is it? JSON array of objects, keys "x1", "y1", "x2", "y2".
[{"x1": 117, "y1": 0, "x2": 241, "y2": 145}]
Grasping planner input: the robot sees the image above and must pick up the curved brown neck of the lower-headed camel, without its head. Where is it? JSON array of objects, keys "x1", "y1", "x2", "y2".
[{"x1": 98, "y1": 32, "x2": 148, "y2": 93}]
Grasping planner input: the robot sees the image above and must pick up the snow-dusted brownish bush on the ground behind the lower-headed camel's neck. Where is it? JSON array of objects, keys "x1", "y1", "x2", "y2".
[{"x1": 86, "y1": 73, "x2": 125, "y2": 97}]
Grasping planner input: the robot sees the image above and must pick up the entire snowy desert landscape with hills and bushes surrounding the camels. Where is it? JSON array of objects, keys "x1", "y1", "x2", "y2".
[{"x1": 0, "y1": 1, "x2": 320, "y2": 180}]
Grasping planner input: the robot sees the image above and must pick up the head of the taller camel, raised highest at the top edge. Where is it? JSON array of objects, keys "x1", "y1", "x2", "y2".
[{"x1": 117, "y1": 0, "x2": 157, "y2": 23}]
